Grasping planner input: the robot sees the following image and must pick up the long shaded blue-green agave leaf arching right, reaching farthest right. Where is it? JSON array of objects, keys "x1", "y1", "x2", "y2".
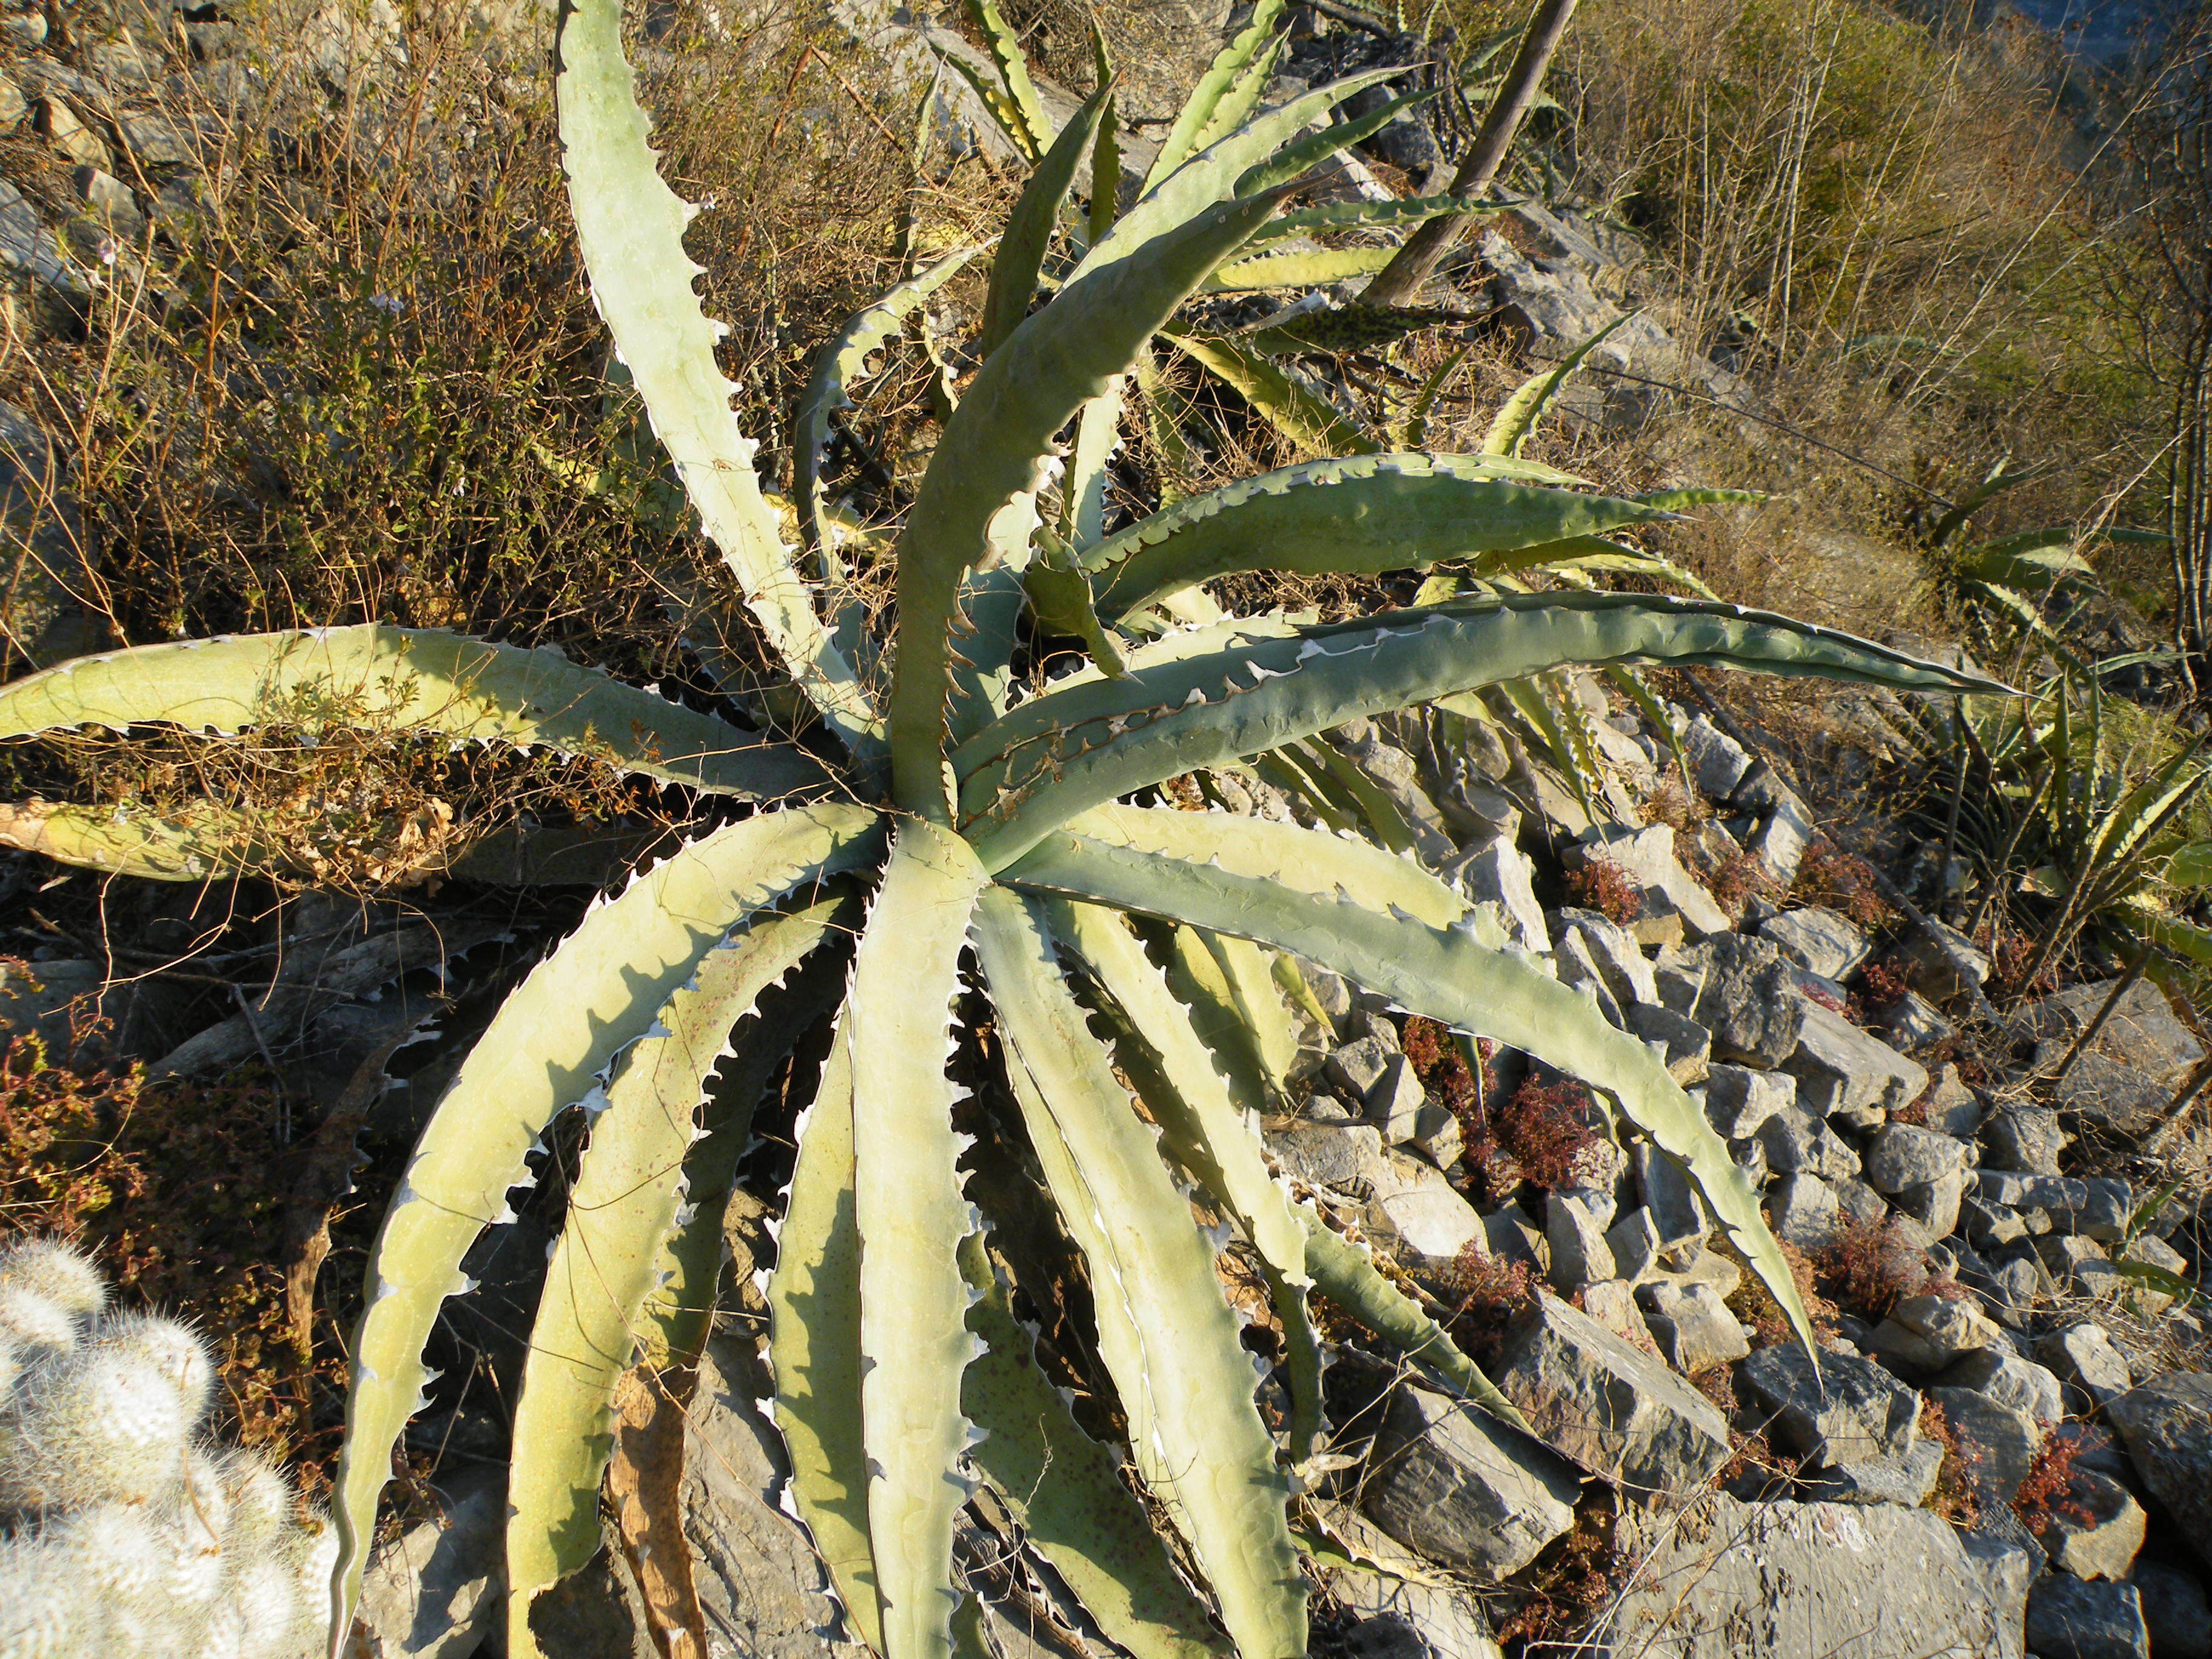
[{"x1": 953, "y1": 593, "x2": 1995, "y2": 870}]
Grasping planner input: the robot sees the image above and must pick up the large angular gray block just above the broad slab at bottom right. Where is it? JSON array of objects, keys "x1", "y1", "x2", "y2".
[{"x1": 1491, "y1": 1296, "x2": 1728, "y2": 1500}]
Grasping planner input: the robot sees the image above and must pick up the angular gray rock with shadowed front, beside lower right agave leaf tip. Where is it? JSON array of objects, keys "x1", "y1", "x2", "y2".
[{"x1": 1361, "y1": 1387, "x2": 1581, "y2": 1580}]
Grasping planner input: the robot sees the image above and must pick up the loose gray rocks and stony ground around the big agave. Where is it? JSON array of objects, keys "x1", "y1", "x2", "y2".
[{"x1": 0, "y1": 4, "x2": 2212, "y2": 1659}]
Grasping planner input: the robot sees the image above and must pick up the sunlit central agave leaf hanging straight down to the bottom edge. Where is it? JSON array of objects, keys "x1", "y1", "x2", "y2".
[{"x1": 850, "y1": 819, "x2": 989, "y2": 1659}]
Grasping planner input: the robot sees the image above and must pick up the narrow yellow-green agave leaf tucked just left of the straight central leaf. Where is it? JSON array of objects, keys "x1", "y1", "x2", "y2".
[{"x1": 768, "y1": 1026, "x2": 883, "y2": 1652}]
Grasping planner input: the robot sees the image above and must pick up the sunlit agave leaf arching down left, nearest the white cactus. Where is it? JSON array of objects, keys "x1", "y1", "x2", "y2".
[{"x1": 332, "y1": 805, "x2": 883, "y2": 1641}]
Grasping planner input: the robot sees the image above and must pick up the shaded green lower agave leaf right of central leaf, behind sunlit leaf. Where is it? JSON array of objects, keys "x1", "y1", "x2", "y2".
[{"x1": 960, "y1": 1232, "x2": 1225, "y2": 1659}]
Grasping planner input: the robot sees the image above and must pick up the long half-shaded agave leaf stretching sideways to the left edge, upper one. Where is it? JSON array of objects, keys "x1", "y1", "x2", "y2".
[{"x1": 0, "y1": 622, "x2": 827, "y2": 801}]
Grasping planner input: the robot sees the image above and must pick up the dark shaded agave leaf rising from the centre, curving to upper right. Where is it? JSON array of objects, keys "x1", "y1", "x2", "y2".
[{"x1": 889, "y1": 197, "x2": 1274, "y2": 814}]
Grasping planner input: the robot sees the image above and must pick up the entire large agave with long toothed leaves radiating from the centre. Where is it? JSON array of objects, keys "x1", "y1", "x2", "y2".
[{"x1": 0, "y1": 0, "x2": 2000, "y2": 1659}]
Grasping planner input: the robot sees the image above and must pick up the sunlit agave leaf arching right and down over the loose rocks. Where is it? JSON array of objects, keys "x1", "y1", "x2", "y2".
[{"x1": 1002, "y1": 834, "x2": 1816, "y2": 1354}]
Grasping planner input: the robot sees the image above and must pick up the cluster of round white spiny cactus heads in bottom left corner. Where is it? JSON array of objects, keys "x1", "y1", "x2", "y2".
[{"x1": 0, "y1": 1241, "x2": 336, "y2": 1659}]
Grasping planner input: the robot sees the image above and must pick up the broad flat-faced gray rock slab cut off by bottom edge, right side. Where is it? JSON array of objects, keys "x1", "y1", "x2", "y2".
[{"x1": 1588, "y1": 1493, "x2": 2020, "y2": 1659}]
